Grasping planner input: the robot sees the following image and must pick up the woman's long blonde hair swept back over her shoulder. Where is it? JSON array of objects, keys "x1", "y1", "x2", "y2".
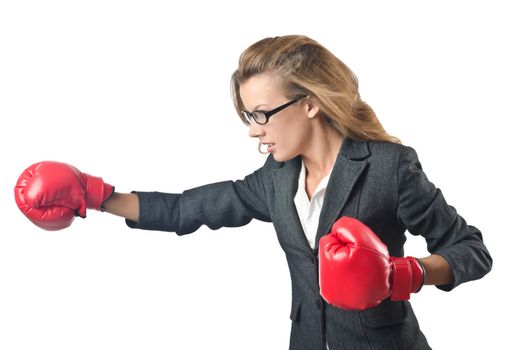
[{"x1": 231, "y1": 35, "x2": 401, "y2": 143}]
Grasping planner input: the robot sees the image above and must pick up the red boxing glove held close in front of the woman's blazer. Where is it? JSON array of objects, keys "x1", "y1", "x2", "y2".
[{"x1": 319, "y1": 216, "x2": 425, "y2": 310}]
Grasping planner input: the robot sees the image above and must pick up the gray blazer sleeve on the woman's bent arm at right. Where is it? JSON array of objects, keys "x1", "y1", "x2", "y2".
[{"x1": 397, "y1": 146, "x2": 492, "y2": 291}]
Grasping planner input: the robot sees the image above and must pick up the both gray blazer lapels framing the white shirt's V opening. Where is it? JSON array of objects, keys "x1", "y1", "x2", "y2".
[{"x1": 273, "y1": 137, "x2": 370, "y2": 253}]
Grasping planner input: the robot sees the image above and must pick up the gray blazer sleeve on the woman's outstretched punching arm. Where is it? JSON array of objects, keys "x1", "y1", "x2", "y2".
[{"x1": 126, "y1": 161, "x2": 271, "y2": 235}]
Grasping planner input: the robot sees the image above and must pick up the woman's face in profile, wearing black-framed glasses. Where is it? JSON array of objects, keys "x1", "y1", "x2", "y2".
[{"x1": 240, "y1": 73, "x2": 318, "y2": 162}]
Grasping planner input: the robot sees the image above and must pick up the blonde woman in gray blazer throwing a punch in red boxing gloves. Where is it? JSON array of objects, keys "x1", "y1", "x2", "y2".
[{"x1": 15, "y1": 35, "x2": 492, "y2": 350}]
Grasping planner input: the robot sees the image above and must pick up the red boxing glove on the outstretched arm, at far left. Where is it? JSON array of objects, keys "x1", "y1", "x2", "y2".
[{"x1": 15, "y1": 161, "x2": 114, "y2": 231}]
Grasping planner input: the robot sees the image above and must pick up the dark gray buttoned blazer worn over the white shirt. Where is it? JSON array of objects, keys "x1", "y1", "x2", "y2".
[{"x1": 126, "y1": 138, "x2": 492, "y2": 350}]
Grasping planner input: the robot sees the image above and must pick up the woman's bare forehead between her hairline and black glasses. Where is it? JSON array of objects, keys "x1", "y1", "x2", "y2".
[{"x1": 240, "y1": 72, "x2": 284, "y2": 110}]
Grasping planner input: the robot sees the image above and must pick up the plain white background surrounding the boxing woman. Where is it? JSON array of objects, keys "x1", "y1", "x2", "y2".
[{"x1": 0, "y1": 1, "x2": 528, "y2": 350}]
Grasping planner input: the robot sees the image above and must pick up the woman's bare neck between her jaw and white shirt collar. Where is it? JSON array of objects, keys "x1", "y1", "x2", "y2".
[{"x1": 301, "y1": 118, "x2": 344, "y2": 178}]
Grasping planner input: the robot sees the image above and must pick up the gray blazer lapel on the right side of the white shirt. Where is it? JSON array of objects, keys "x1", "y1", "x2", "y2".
[{"x1": 315, "y1": 138, "x2": 370, "y2": 253}]
